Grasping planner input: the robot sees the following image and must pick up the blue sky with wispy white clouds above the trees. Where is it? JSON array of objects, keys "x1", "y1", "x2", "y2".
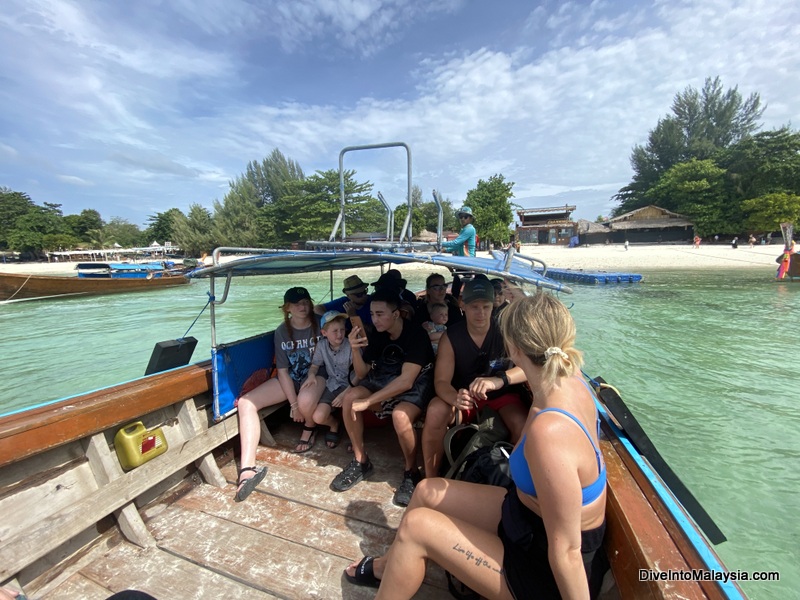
[{"x1": 0, "y1": 0, "x2": 800, "y2": 226}]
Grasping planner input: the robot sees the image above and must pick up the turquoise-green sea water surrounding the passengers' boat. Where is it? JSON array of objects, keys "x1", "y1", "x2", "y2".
[{"x1": 0, "y1": 269, "x2": 800, "y2": 600}]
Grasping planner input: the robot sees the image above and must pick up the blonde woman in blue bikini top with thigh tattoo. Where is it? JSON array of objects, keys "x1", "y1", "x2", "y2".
[{"x1": 344, "y1": 292, "x2": 606, "y2": 599}]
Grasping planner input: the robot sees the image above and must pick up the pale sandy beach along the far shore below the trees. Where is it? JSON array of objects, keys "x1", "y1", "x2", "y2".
[{"x1": 0, "y1": 244, "x2": 782, "y2": 275}]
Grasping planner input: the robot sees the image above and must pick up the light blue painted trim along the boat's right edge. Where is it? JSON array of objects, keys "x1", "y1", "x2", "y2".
[{"x1": 594, "y1": 398, "x2": 747, "y2": 600}]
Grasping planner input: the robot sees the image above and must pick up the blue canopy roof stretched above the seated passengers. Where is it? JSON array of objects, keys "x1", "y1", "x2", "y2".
[{"x1": 187, "y1": 248, "x2": 572, "y2": 293}]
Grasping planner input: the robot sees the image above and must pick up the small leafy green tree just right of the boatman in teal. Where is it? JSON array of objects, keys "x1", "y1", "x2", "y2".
[{"x1": 464, "y1": 174, "x2": 514, "y2": 243}]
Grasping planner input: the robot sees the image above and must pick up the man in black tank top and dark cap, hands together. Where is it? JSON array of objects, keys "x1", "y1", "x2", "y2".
[{"x1": 422, "y1": 275, "x2": 528, "y2": 477}]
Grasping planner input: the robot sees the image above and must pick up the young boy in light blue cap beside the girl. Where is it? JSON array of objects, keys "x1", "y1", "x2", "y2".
[{"x1": 300, "y1": 310, "x2": 353, "y2": 448}]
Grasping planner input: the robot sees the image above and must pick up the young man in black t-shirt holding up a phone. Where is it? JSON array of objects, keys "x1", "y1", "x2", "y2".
[{"x1": 330, "y1": 288, "x2": 434, "y2": 506}]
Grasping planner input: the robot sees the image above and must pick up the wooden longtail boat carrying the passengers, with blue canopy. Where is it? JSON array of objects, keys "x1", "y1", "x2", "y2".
[{"x1": 0, "y1": 143, "x2": 745, "y2": 600}]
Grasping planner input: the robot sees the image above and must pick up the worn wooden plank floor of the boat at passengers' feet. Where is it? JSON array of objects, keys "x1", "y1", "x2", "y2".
[{"x1": 29, "y1": 415, "x2": 450, "y2": 600}]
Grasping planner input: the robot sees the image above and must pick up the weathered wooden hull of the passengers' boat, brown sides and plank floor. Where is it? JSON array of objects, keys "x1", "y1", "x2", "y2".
[{"x1": 0, "y1": 362, "x2": 744, "y2": 599}]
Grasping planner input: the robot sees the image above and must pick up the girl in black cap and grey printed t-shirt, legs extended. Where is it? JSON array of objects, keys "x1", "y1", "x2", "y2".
[{"x1": 235, "y1": 287, "x2": 325, "y2": 502}]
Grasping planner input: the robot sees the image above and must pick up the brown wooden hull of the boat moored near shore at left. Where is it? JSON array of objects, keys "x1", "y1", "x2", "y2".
[{"x1": 0, "y1": 273, "x2": 189, "y2": 301}]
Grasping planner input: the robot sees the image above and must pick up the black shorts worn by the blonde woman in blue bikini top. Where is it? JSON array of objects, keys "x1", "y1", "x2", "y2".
[{"x1": 497, "y1": 485, "x2": 608, "y2": 600}]
